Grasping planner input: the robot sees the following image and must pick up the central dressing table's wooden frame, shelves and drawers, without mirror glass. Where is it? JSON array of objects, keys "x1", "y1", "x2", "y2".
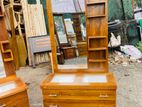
[{"x1": 41, "y1": 0, "x2": 117, "y2": 107}]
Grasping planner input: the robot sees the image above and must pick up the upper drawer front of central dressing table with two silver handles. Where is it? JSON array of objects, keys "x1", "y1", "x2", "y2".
[{"x1": 43, "y1": 90, "x2": 116, "y2": 102}]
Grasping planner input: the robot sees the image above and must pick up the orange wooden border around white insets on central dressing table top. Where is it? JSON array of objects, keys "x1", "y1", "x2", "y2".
[{"x1": 41, "y1": 73, "x2": 116, "y2": 90}]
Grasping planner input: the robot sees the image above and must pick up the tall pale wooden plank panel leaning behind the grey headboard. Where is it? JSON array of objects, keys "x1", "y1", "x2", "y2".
[{"x1": 21, "y1": 0, "x2": 47, "y2": 65}]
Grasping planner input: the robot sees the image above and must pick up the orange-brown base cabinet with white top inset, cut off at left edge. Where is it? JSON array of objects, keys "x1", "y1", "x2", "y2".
[{"x1": 0, "y1": 76, "x2": 29, "y2": 107}]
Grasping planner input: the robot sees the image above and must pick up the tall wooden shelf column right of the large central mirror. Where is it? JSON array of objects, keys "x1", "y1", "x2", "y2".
[{"x1": 86, "y1": 0, "x2": 108, "y2": 72}]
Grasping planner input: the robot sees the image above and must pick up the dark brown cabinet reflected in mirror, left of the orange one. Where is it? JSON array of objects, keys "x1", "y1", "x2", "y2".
[{"x1": 62, "y1": 47, "x2": 76, "y2": 59}]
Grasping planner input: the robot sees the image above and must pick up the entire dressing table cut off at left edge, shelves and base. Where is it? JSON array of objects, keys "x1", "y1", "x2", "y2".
[{"x1": 0, "y1": 3, "x2": 29, "y2": 107}]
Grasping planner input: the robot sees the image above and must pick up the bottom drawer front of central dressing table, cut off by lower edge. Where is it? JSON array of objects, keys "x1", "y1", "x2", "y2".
[{"x1": 44, "y1": 103, "x2": 116, "y2": 107}]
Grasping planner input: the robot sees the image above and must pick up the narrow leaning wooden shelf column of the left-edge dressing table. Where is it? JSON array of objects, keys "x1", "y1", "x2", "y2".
[{"x1": 0, "y1": 3, "x2": 15, "y2": 76}]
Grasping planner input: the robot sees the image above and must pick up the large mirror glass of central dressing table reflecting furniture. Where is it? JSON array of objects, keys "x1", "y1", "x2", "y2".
[{"x1": 52, "y1": 0, "x2": 88, "y2": 69}]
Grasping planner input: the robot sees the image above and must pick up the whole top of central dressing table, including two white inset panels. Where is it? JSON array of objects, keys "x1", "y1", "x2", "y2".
[{"x1": 41, "y1": 73, "x2": 116, "y2": 89}]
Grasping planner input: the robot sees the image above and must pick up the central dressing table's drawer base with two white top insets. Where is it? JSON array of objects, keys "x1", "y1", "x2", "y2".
[{"x1": 41, "y1": 73, "x2": 116, "y2": 107}]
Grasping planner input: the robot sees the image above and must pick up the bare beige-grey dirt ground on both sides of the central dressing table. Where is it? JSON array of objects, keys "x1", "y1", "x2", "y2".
[{"x1": 17, "y1": 63, "x2": 142, "y2": 107}]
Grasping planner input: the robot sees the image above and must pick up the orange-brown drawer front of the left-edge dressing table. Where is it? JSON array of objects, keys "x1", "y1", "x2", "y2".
[{"x1": 0, "y1": 91, "x2": 29, "y2": 107}]
